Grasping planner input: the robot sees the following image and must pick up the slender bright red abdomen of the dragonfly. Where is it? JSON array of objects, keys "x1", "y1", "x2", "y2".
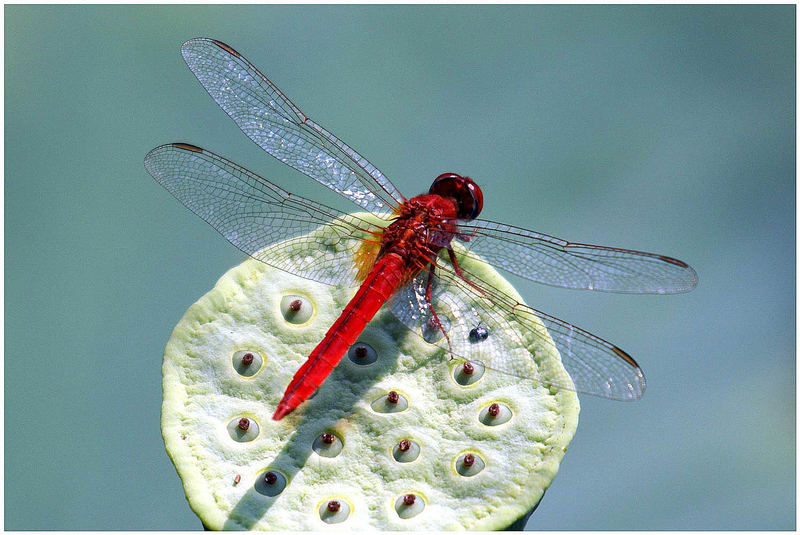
[{"x1": 272, "y1": 252, "x2": 406, "y2": 420}]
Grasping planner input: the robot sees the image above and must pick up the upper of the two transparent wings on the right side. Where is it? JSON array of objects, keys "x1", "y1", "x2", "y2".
[{"x1": 459, "y1": 219, "x2": 697, "y2": 294}]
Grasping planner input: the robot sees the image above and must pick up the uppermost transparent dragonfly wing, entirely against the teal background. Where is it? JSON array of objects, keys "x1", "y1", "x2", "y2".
[{"x1": 181, "y1": 39, "x2": 405, "y2": 214}]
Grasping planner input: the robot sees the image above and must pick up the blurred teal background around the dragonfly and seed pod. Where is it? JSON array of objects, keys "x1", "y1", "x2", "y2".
[{"x1": 5, "y1": 6, "x2": 796, "y2": 530}]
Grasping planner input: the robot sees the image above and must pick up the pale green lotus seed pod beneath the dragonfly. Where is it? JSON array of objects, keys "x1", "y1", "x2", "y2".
[{"x1": 161, "y1": 214, "x2": 579, "y2": 531}]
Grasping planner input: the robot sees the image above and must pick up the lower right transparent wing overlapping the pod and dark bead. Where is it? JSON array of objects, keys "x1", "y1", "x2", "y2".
[{"x1": 389, "y1": 262, "x2": 645, "y2": 400}]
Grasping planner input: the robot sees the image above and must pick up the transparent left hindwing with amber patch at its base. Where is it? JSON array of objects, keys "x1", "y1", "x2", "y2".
[{"x1": 144, "y1": 143, "x2": 392, "y2": 286}]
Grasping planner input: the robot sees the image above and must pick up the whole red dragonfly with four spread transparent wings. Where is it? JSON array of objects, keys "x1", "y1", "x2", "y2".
[{"x1": 145, "y1": 39, "x2": 697, "y2": 420}]
